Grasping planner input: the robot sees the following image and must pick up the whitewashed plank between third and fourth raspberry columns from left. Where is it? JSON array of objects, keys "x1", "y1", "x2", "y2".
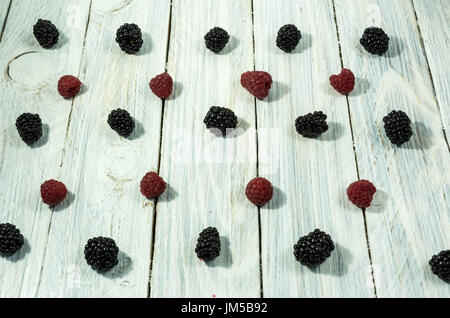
[{"x1": 254, "y1": 0, "x2": 374, "y2": 297}]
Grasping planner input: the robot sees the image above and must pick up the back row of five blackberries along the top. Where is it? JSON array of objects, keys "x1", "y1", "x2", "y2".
[{"x1": 33, "y1": 19, "x2": 389, "y2": 55}]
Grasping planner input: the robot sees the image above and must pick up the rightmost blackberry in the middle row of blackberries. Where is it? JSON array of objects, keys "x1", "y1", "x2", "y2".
[{"x1": 383, "y1": 110, "x2": 412, "y2": 146}]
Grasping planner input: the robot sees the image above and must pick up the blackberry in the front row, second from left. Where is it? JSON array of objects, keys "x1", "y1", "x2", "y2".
[{"x1": 84, "y1": 236, "x2": 119, "y2": 272}]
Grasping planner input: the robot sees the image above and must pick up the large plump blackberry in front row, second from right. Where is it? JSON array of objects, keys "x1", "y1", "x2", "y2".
[{"x1": 294, "y1": 229, "x2": 334, "y2": 267}]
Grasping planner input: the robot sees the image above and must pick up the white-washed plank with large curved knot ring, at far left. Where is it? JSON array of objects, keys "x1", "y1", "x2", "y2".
[{"x1": 0, "y1": 0, "x2": 89, "y2": 297}]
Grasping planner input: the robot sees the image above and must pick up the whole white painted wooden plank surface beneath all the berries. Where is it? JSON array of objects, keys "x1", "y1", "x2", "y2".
[{"x1": 0, "y1": 0, "x2": 450, "y2": 297}]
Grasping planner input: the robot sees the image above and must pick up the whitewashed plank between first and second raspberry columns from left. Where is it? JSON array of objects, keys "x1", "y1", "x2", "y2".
[{"x1": 38, "y1": 0, "x2": 170, "y2": 297}]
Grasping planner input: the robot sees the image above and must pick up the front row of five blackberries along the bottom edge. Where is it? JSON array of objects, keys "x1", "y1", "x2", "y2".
[{"x1": 0, "y1": 223, "x2": 450, "y2": 281}]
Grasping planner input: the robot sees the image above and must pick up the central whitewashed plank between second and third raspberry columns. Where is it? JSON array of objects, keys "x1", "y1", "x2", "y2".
[{"x1": 150, "y1": 0, "x2": 260, "y2": 297}]
